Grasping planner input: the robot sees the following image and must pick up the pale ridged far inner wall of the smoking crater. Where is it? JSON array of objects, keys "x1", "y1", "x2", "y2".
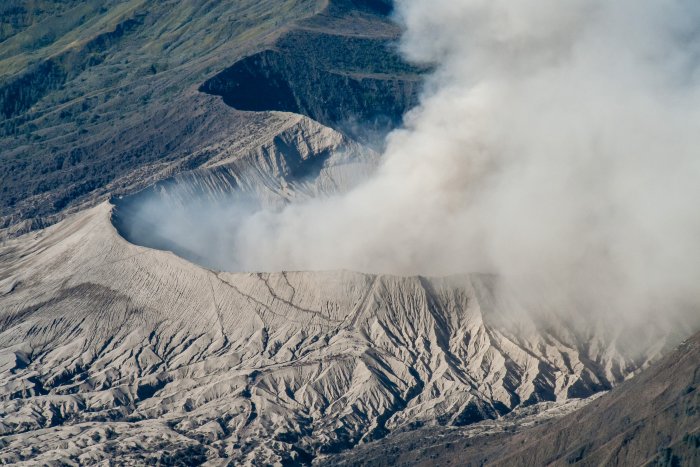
[{"x1": 115, "y1": 112, "x2": 379, "y2": 215}]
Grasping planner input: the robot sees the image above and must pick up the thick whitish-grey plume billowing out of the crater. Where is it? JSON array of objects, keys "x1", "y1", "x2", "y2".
[{"x1": 131, "y1": 0, "x2": 700, "y2": 330}]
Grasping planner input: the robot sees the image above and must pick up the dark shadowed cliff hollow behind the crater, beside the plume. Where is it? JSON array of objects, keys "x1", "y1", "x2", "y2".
[{"x1": 200, "y1": 1, "x2": 426, "y2": 137}]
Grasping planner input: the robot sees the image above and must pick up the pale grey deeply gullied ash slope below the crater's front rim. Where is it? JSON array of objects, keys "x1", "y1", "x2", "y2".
[{"x1": 0, "y1": 203, "x2": 680, "y2": 464}]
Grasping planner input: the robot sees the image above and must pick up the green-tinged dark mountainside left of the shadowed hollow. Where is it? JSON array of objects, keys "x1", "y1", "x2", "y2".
[{"x1": 0, "y1": 0, "x2": 323, "y2": 234}]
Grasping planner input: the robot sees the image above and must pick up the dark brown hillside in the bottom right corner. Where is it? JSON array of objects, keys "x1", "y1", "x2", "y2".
[{"x1": 329, "y1": 334, "x2": 700, "y2": 466}]
